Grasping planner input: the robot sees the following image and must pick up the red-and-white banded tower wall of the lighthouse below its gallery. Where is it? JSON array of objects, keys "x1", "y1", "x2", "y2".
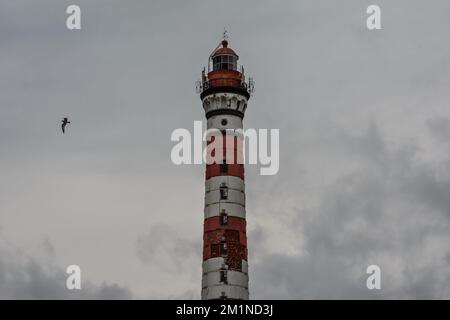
[{"x1": 202, "y1": 93, "x2": 249, "y2": 299}]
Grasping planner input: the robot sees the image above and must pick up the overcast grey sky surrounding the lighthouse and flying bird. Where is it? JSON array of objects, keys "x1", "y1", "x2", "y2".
[{"x1": 0, "y1": 0, "x2": 450, "y2": 299}]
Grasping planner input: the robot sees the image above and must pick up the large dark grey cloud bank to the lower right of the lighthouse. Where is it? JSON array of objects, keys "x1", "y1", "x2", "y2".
[{"x1": 250, "y1": 125, "x2": 450, "y2": 299}]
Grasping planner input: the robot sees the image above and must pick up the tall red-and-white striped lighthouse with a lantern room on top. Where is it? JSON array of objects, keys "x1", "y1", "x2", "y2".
[{"x1": 197, "y1": 35, "x2": 253, "y2": 300}]
